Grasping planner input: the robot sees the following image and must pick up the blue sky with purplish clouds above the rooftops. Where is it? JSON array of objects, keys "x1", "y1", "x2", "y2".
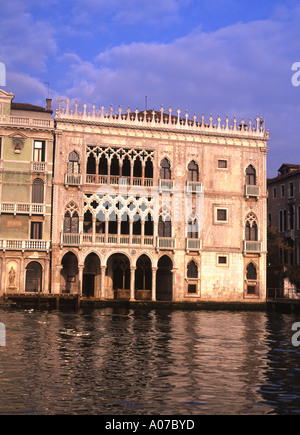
[{"x1": 0, "y1": 0, "x2": 300, "y2": 177}]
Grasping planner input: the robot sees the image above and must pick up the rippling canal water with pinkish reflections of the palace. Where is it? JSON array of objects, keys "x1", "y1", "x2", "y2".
[{"x1": 0, "y1": 308, "x2": 300, "y2": 415}]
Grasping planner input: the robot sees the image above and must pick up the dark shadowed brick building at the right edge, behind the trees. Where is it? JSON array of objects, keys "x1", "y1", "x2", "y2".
[{"x1": 268, "y1": 163, "x2": 300, "y2": 288}]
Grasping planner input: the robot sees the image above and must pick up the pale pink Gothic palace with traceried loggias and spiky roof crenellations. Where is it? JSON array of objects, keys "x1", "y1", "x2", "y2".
[{"x1": 51, "y1": 100, "x2": 269, "y2": 302}]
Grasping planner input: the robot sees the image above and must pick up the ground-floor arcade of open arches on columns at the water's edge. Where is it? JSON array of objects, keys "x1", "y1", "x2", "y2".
[{"x1": 60, "y1": 252, "x2": 173, "y2": 301}]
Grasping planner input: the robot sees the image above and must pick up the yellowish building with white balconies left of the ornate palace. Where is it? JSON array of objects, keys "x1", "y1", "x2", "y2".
[{"x1": 0, "y1": 90, "x2": 54, "y2": 295}]
